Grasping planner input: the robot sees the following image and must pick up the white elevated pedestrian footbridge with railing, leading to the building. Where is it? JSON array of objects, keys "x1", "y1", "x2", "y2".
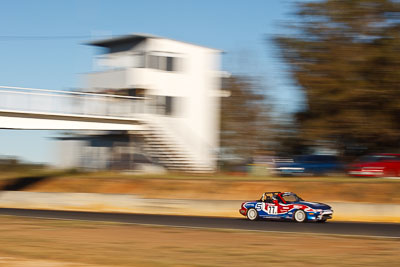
[{"x1": 0, "y1": 86, "x2": 149, "y2": 130}]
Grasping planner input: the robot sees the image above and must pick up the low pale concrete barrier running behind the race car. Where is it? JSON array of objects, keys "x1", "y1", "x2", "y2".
[{"x1": 0, "y1": 191, "x2": 400, "y2": 222}]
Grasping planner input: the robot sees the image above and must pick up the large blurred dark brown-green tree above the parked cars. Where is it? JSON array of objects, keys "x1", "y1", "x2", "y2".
[{"x1": 275, "y1": 0, "x2": 400, "y2": 157}]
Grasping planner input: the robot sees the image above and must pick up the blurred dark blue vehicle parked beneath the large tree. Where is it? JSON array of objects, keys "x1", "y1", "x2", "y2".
[{"x1": 274, "y1": 155, "x2": 344, "y2": 176}]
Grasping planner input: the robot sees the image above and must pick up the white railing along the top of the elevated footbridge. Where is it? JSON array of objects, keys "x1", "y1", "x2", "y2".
[{"x1": 0, "y1": 86, "x2": 148, "y2": 118}]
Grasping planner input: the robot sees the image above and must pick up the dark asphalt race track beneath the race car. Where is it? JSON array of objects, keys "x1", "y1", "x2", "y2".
[{"x1": 0, "y1": 208, "x2": 400, "y2": 238}]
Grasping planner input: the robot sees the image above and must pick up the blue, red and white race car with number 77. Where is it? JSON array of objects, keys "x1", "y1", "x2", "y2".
[{"x1": 239, "y1": 192, "x2": 333, "y2": 222}]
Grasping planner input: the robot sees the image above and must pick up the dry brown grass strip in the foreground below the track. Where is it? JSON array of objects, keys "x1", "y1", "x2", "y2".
[{"x1": 0, "y1": 216, "x2": 400, "y2": 267}]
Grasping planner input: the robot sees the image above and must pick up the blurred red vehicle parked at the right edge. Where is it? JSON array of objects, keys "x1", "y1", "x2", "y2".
[{"x1": 347, "y1": 153, "x2": 400, "y2": 177}]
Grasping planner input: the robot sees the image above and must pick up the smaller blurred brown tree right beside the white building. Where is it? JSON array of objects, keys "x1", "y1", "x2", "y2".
[{"x1": 221, "y1": 76, "x2": 270, "y2": 162}]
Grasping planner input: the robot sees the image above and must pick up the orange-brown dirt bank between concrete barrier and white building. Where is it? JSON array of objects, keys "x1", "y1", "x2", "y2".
[{"x1": 0, "y1": 173, "x2": 400, "y2": 204}]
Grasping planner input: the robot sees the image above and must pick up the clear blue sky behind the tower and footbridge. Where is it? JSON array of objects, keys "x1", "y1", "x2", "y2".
[{"x1": 0, "y1": 0, "x2": 299, "y2": 162}]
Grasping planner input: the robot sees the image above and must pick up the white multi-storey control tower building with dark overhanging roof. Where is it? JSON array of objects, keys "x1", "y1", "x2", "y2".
[{"x1": 63, "y1": 34, "x2": 221, "y2": 171}]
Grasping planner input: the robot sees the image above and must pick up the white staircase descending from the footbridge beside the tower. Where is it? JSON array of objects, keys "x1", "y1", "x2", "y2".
[{"x1": 141, "y1": 123, "x2": 214, "y2": 173}]
